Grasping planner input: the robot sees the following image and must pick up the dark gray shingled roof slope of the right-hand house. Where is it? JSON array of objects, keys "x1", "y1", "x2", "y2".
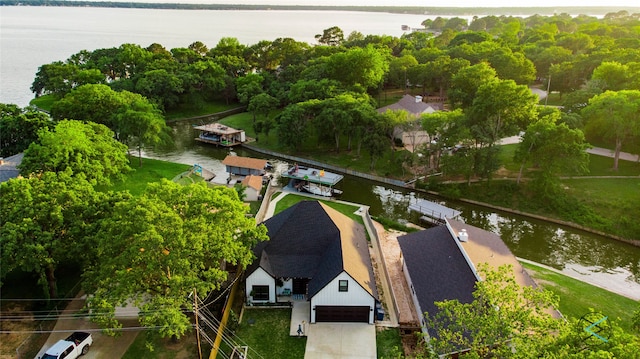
[{"x1": 398, "y1": 226, "x2": 476, "y2": 324}]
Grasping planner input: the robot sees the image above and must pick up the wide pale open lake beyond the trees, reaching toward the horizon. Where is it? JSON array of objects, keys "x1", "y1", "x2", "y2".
[{"x1": 0, "y1": 6, "x2": 428, "y2": 106}]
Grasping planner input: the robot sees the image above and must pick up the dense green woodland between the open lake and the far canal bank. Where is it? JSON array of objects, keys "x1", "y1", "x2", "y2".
[{"x1": 23, "y1": 10, "x2": 640, "y2": 202}]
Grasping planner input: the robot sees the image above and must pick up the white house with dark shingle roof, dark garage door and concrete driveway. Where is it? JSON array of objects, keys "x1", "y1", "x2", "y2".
[{"x1": 245, "y1": 201, "x2": 378, "y2": 324}]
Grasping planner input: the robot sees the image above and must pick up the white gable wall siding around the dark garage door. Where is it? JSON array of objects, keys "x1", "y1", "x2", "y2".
[{"x1": 311, "y1": 272, "x2": 376, "y2": 324}]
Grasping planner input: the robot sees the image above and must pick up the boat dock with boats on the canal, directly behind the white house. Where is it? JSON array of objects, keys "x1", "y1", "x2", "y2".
[{"x1": 281, "y1": 165, "x2": 344, "y2": 197}]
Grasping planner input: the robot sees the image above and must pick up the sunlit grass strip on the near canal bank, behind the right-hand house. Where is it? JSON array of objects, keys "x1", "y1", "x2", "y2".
[{"x1": 522, "y1": 263, "x2": 638, "y2": 333}]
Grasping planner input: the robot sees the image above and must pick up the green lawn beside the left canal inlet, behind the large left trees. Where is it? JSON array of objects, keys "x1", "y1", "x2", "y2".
[{"x1": 98, "y1": 157, "x2": 191, "y2": 196}]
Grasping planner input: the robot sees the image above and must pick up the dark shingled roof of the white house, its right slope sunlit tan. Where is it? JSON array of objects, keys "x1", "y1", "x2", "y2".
[{"x1": 247, "y1": 201, "x2": 378, "y2": 298}]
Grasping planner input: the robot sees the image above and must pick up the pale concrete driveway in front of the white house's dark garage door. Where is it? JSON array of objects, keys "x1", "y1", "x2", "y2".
[{"x1": 304, "y1": 323, "x2": 376, "y2": 359}]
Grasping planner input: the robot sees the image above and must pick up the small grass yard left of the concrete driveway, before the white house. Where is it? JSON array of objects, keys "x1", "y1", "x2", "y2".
[{"x1": 229, "y1": 308, "x2": 307, "y2": 359}]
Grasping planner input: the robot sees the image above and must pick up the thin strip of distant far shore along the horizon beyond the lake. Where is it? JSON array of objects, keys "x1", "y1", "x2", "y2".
[{"x1": 0, "y1": 0, "x2": 640, "y2": 16}]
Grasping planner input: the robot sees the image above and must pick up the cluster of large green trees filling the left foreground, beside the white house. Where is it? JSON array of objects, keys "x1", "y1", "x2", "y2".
[{"x1": 0, "y1": 113, "x2": 266, "y2": 338}]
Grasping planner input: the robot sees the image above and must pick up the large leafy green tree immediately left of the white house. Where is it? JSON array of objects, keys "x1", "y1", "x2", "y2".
[{"x1": 83, "y1": 180, "x2": 267, "y2": 338}]
